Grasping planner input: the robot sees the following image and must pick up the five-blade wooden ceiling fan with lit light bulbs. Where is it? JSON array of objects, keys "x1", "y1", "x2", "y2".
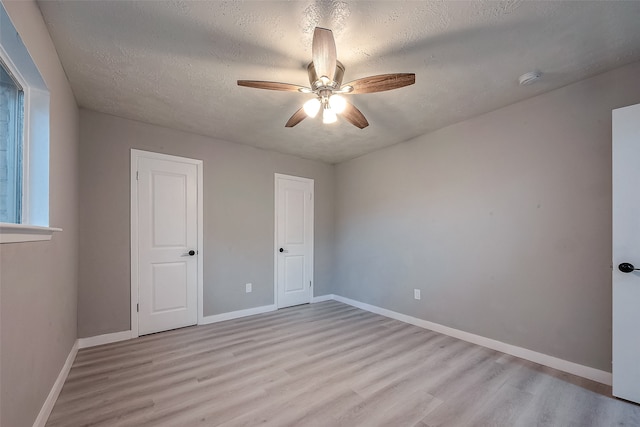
[{"x1": 238, "y1": 27, "x2": 416, "y2": 129}]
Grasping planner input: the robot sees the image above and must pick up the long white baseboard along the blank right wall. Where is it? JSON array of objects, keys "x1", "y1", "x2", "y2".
[{"x1": 333, "y1": 295, "x2": 612, "y2": 385}]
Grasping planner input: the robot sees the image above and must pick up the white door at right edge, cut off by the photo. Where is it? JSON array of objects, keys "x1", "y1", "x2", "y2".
[{"x1": 613, "y1": 104, "x2": 640, "y2": 403}]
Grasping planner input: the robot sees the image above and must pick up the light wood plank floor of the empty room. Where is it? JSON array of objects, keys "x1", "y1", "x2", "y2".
[{"x1": 47, "y1": 301, "x2": 640, "y2": 427}]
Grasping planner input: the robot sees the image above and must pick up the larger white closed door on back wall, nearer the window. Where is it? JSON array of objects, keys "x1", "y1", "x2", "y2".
[{"x1": 132, "y1": 152, "x2": 200, "y2": 335}]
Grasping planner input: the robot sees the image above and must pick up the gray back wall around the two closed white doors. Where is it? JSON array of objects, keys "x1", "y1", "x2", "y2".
[{"x1": 78, "y1": 109, "x2": 334, "y2": 337}]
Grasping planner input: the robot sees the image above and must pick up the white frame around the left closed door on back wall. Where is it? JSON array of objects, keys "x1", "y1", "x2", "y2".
[{"x1": 131, "y1": 148, "x2": 204, "y2": 338}]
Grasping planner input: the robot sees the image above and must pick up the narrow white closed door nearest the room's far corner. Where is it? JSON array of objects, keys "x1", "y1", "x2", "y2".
[{"x1": 275, "y1": 174, "x2": 313, "y2": 308}]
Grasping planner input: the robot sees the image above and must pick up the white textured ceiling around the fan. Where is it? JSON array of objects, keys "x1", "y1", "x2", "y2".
[{"x1": 39, "y1": 0, "x2": 640, "y2": 163}]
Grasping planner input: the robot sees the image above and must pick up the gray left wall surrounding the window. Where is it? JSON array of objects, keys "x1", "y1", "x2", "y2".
[{"x1": 0, "y1": 1, "x2": 79, "y2": 427}]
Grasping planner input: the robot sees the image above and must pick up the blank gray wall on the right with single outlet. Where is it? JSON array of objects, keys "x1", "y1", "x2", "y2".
[{"x1": 334, "y1": 63, "x2": 640, "y2": 371}]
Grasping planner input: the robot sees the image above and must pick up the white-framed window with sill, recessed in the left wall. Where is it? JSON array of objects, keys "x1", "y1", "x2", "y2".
[{"x1": 0, "y1": 3, "x2": 60, "y2": 243}]
